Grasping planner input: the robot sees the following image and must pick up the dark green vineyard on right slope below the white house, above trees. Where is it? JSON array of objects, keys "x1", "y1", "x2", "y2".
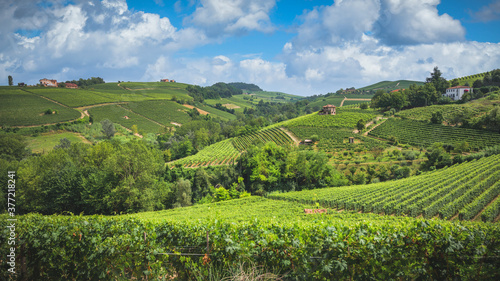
[{"x1": 369, "y1": 118, "x2": 500, "y2": 150}]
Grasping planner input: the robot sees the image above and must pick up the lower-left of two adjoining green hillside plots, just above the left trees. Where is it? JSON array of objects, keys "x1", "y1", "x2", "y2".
[{"x1": 89, "y1": 105, "x2": 162, "y2": 133}]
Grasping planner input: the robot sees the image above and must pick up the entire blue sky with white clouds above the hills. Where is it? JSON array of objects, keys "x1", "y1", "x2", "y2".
[{"x1": 0, "y1": 0, "x2": 500, "y2": 96}]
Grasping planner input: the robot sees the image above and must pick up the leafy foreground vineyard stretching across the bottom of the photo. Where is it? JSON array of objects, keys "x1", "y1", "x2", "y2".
[{"x1": 4, "y1": 197, "x2": 500, "y2": 280}]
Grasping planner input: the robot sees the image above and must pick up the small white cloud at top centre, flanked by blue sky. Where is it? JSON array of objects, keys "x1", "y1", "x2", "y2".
[{"x1": 187, "y1": 0, "x2": 276, "y2": 37}]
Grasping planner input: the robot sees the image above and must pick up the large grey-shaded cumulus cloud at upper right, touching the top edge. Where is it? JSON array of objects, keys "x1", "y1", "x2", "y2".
[{"x1": 294, "y1": 0, "x2": 465, "y2": 47}]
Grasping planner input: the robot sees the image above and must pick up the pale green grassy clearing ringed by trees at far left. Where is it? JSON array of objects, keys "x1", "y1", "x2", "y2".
[{"x1": 26, "y1": 132, "x2": 88, "y2": 153}]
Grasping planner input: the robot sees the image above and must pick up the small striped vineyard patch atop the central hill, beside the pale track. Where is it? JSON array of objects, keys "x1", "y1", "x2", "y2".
[{"x1": 233, "y1": 127, "x2": 292, "y2": 152}]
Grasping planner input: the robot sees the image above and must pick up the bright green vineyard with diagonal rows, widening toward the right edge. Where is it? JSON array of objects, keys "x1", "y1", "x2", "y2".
[{"x1": 269, "y1": 152, "x2": 500, "y2": 221}]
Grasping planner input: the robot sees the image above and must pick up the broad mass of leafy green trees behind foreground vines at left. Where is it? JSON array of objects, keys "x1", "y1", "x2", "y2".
[{"x1": 7, "y1": 141, "x2": 173, "y2": 214}]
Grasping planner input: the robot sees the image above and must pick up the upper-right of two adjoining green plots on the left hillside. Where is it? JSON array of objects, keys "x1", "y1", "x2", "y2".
[{"x1": 123, "y1": 100, "x2": 191, "y2": 126}]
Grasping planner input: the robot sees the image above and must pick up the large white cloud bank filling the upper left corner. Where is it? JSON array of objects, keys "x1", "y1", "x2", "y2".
[{"x1": 0, "y1": 0, "x2": 209, "y2": 83}]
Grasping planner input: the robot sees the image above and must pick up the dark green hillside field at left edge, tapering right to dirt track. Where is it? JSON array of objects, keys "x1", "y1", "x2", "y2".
[{"x1": 0, "y1": 87, "x2": 81, "y2": 126}]
